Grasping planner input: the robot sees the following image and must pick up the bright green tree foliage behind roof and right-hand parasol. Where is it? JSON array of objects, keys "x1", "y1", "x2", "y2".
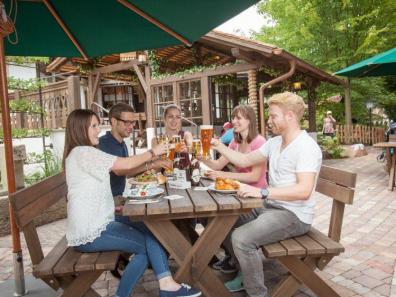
[{"x1": 255, "y1": 0, "x2": 396, "y2": 121}]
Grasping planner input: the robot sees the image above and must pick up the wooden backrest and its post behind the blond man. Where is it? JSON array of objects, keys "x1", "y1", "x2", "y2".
[{"x1": 316, "y1": 165, "x2": 356, "y2": 242}]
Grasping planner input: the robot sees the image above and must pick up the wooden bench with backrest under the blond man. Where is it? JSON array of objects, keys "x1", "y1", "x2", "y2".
[{"x1": 262, "y1": 166, "x2": 356, "y2": 297}]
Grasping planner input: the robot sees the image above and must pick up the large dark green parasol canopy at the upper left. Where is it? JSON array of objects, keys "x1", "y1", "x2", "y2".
[{"x1": 5, "y1": 0, "x2": 258, "y2": 57}]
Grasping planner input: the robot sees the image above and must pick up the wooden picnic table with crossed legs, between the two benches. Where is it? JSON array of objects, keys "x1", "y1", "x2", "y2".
[{"x1": 122, "y1": 181, "x2": 263, "y2": 297}]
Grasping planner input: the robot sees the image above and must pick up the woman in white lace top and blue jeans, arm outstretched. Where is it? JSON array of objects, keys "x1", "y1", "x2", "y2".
[{"x1": 62, "y1": 109, "x2": 201, "y2": 297}]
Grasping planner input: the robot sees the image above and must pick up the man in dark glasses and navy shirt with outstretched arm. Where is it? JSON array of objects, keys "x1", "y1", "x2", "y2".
[{"x1": 99, "y1": 103, "x2": 170, "y2": 196}]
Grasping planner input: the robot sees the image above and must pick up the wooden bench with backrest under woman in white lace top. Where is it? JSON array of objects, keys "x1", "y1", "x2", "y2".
[{"x1": 10, "y1": 172, "x2": 120, "y2": 297}]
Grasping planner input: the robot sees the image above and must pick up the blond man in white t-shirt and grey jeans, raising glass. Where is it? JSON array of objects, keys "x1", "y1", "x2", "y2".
[{"x1": 212, "y1": 92, "x2": 322, "y2": 297}]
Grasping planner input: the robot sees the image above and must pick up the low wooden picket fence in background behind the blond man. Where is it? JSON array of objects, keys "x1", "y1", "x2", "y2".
[{"x1": 336, "y1": 125, "x2": 385, "y2": 144}]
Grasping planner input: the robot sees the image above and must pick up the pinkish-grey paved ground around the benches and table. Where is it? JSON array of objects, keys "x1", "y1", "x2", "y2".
[{"x1": 0, "y1": 149, "x2": 396, "y2": 297}]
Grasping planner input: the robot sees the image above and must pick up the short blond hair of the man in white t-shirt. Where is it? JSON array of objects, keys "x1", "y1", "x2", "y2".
[{"x1": 268, "y1": 92, "x2": 307, "y2": 120}]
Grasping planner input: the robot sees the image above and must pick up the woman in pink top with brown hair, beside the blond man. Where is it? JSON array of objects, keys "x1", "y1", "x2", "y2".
[{"x1": 201, "y1": 105, "x2": 268, "y2": 273}]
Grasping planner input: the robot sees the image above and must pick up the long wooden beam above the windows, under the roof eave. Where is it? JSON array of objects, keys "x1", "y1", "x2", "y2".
[{"x1": 150, "y1": 63, "x2": 258, "y2": 86}]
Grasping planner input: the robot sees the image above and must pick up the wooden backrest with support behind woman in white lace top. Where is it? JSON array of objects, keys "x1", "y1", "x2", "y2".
[{"x1": 10, "y1": 172, "x2": 67, "y2": 265}]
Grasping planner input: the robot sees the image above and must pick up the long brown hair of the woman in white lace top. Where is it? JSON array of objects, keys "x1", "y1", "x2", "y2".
[{"x1": 62, "y1": 109, "x2": 100, "y2": 168}]
